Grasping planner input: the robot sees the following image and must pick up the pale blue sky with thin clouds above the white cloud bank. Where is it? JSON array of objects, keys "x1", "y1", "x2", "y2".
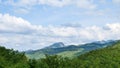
[{"x1": 0, "y1": 0, "x2": 120, "y2": 26}]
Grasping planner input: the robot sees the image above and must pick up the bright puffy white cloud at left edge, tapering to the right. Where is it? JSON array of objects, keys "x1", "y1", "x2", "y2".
[{"x1": 0, "y1": 14, "x2": 37, "y2": 33}]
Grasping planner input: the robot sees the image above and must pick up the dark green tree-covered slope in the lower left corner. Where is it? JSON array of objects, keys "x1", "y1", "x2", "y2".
[{"x1": 0, "y1": 47, "x2": 29, "y2": 68}]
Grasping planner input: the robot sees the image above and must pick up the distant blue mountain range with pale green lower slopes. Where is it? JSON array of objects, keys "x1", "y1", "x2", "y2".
[{"x1": 25, "y1": 40, "x2": 117, "y2": 59}]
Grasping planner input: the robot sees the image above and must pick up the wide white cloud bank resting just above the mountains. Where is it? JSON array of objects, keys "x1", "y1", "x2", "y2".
[{"x1": 0, "y1": 14, "x2": 120, "y2": 50}]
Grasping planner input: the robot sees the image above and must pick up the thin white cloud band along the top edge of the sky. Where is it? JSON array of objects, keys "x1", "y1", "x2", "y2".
[{"x1": 0, "y1": 0, "x2": 96, "y2": 9}]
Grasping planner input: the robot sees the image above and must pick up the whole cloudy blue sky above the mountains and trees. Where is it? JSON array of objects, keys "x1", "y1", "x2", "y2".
[{"x1": 0, "y1": 0, "x2": 120, "y2": 50}]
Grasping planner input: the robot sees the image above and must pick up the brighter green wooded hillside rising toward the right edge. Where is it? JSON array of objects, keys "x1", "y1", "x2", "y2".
[{"x1": 73, "y1": 41, "x2": 120, "y2": 68}]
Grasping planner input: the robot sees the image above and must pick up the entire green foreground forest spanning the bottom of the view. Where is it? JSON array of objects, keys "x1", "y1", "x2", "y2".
[{"x1": 0, "y1": 41, "x2": 120, "y2": 68}]
